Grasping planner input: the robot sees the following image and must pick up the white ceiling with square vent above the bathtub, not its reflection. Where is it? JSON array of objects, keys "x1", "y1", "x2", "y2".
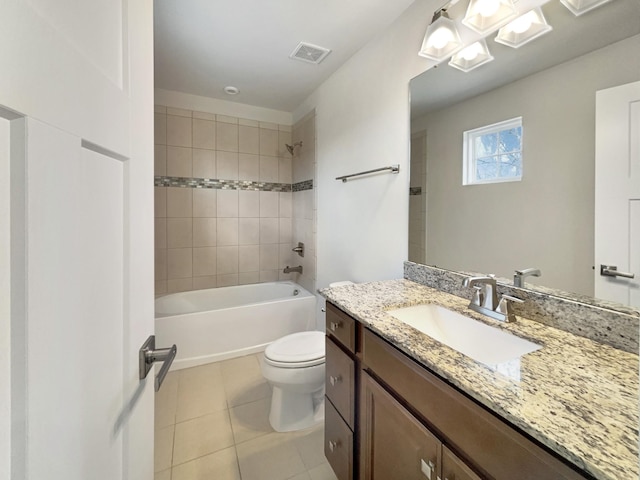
[{"x1": 154, "y1": 0, "x2": 418, "y2": 112}]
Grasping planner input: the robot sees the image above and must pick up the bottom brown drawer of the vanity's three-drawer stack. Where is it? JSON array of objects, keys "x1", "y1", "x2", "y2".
[{"x1": 324, "y1": 394, "x2": 353, "y2": 480}]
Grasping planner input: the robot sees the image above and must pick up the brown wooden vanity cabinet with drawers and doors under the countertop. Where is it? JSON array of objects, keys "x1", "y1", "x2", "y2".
[{"x1": 325, "y1": 303, "x2": 591, "y2": 480}]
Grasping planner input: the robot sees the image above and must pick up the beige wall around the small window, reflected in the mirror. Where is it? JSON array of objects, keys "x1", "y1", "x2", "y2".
[{"x1": 414, "y1": 36, "x2": 640, "y2": 295}]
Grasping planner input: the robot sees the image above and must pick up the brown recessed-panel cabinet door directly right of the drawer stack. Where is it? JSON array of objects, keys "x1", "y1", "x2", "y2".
[{"x1": 361, "y1": 373, "x2": 442, "y2": 480}]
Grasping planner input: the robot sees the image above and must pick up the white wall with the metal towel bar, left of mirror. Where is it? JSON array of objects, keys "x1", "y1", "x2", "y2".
[{"x1": 294, "y1": 1, "x2": 440, "y2": 300}]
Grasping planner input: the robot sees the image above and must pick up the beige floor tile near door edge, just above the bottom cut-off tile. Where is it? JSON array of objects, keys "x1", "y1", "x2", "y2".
[{"x1": 173, "y1": 410, "x2": 233, "y2": 465}]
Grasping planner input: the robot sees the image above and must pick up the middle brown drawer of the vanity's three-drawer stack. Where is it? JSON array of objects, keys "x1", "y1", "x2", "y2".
[{"x1": 325, "y1": 337, "x2": 355, "y2": 429}]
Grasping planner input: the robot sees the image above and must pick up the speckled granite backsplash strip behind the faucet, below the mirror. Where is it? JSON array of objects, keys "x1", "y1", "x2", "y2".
[{"x1": 404, "y1": 262, "x2": 640, "y2": 353}]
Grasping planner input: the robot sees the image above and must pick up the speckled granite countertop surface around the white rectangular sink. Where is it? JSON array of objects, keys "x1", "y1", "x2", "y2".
[{"x1": 320, "y1": 280, "x2": 640, "y2": 480}]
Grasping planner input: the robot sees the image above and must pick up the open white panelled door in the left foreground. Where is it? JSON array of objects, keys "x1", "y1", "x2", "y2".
[{"x1": 0, "y1": 0, "x2": 154, "y2": 480}]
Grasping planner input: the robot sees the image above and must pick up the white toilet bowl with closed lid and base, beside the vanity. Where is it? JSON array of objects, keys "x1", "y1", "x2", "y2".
[{"x1": 261, "y1": 332, "x2": 325, "y2": 432}]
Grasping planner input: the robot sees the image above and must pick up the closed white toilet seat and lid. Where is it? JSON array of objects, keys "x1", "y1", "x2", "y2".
[{"x1": 264, "y1": 331, "x2": 325, "y2": 368}]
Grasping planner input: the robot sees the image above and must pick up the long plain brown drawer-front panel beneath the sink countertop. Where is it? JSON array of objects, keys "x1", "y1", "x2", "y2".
[{"x1": 363, "y1": 330, "x2": 585, "y2": 480}]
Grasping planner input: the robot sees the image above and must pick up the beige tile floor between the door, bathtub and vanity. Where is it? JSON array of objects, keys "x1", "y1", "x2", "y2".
[{"x1": 155, "y1": 354, "x2": 336, "y2": 480}]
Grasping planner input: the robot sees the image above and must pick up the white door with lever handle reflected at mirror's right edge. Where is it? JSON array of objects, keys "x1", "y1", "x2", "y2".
[{"x1": 595, "y1": 82, "x2": 640, "y2": 307}]
